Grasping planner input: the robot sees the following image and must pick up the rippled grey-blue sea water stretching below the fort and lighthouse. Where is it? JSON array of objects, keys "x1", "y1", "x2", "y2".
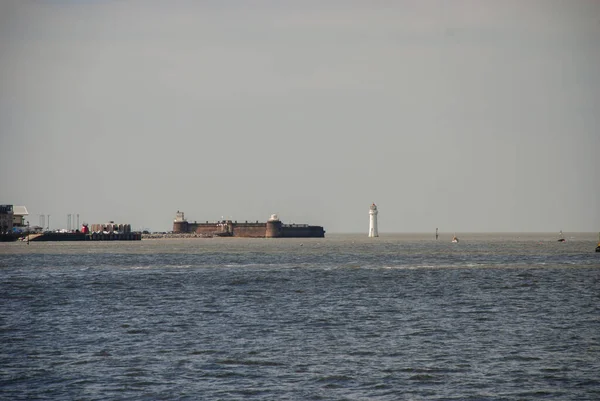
[{"x1": 0, "y1": 234, "x2": 600, "y2": 400}]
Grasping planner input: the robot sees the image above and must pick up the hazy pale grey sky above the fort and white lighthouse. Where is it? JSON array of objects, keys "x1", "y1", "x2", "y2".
[{"x1": 0, "y1": 0, "x2": 600, "y2": 235}]
